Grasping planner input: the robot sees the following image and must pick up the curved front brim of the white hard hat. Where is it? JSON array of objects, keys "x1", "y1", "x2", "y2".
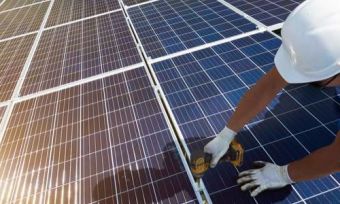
[{"x1": 274, "y1": 45, "x2": 320, "y2": 84}]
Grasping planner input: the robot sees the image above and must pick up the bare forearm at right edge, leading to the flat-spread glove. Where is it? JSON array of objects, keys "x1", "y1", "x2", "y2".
[{"x1": 288, "y1": 131, "x2": 340, "y2": 182}]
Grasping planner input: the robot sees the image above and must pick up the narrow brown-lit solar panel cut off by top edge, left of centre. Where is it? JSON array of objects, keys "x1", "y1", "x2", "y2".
[{"x1": 46, "y1": 0, "x2": 120, "y2": 27}]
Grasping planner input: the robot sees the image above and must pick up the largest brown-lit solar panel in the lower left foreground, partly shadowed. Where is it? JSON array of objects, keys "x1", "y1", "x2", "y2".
[{"x1": 0, "y1": 68, "x2": 197, "y2": 203}]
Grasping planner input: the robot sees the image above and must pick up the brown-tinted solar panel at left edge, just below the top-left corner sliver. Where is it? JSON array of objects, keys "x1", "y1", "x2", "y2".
[{"x1": 0, "y1": 2, "x2": 49, "y2": 39}]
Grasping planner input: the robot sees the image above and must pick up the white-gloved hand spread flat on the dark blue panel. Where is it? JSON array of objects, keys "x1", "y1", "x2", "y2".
[{"x1": 237, "y1": 161, "x2": 294, "y2": 197}]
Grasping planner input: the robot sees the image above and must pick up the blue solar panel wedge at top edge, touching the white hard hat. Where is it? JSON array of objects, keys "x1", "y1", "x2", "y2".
[{"x1": 224, "y1": 0, "x2": 304, "y2": 26}]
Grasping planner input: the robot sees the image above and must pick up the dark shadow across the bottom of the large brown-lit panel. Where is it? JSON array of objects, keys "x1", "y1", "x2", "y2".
[{"x1": 92, "y1": 142, "x2": 192, "y2": 203}]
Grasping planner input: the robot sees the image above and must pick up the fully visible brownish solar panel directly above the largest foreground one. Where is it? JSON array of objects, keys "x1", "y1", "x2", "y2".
[{"x1": 21, "y1": 11, "x2": 141, "y2": 95}]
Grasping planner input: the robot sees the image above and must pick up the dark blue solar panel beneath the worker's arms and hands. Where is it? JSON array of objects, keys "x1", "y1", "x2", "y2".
[{"x1": 153, "y1": 33, "x2": 340, "y2": 203}]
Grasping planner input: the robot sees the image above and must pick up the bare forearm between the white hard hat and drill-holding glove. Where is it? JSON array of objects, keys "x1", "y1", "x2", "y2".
[{"x1": 227, "y1": 67, "x2": 287, "y2": 132}]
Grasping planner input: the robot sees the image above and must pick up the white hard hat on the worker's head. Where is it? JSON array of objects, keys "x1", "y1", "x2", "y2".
[{"x1": 275, "y1": 0, "x2": 340, "y2": 83}]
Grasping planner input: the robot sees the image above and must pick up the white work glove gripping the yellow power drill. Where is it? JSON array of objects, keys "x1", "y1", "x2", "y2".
[{"x1": 204, "y1": 127, "x2": 236, "y2": 168}]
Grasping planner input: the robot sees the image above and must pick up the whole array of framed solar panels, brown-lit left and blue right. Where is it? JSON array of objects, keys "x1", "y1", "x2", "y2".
[{"x1": 0, "y1": 0, "x2": 340, "y2": 203}]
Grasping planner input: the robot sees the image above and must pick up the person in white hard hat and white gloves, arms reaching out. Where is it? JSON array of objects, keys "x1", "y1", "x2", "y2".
[{"x1": 204, "y1": 0, "x2": 340, "y2": 196}]
